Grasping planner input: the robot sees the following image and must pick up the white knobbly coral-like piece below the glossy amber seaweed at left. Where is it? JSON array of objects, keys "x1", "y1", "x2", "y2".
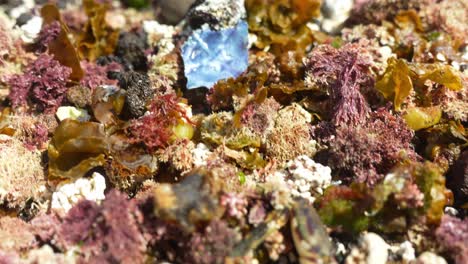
[{"x1": 51, "y1": 172, "x2": 106, "y2": 213}]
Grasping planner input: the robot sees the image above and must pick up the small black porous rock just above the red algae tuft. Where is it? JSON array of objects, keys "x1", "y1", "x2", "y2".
[{"x1": 119, "y1": 71, "x2": 154, "y2": 118}]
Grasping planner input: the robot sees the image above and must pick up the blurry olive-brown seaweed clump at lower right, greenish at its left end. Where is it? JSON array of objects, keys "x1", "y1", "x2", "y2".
[{"x1": 317, "y1": 162, "x2": 452, "y2": 233}]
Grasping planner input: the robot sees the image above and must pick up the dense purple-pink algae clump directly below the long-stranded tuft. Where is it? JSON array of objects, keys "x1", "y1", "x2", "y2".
[{"x1": 322, "y1": 109, "x2": 418, "y2": 185}]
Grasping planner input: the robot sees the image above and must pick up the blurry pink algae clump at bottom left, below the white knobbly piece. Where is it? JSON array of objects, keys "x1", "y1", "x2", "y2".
[{"x1": 60, "y1": 191, "x2": 146, "y2": 263}]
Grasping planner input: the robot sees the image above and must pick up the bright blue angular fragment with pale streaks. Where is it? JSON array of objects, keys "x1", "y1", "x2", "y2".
[{"x1": 182, "y1": 21, "x2": 249, "y2": 89}]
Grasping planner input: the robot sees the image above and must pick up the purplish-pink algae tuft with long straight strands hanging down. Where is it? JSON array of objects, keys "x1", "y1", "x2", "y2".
[{"x1": 304, "y1": 43, "x2": 374, "y2": 125}]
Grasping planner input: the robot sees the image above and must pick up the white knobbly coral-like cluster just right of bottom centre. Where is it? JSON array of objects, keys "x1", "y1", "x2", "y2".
[{"x1": 286, "y1": 155, "x2": 331, "y2": 203}]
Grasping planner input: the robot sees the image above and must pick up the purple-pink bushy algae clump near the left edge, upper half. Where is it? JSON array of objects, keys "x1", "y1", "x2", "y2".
[{"x1": 8, "y1": 54, "x2": 71, "y2": 112}]
